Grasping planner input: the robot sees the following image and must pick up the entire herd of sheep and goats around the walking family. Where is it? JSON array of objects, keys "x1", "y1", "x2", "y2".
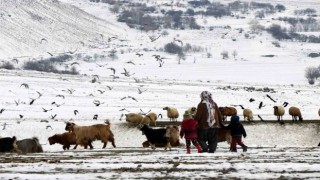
[{"x1": 0, "y1": 106, "x2": 320, "y2": 153}]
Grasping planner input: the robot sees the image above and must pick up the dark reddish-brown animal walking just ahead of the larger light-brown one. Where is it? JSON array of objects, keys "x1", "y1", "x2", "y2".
[{"x1": 48, "y1": 132, "x2": 80, "y2": 150}]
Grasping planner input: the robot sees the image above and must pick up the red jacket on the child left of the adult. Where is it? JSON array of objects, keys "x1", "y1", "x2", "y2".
[{"x1": 180, "y1": 118, "x2": 198, "y2": 139}]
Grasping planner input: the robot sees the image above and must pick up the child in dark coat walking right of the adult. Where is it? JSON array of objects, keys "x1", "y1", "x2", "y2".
[{"x1": 224, "y1": 115, "x2": 248, "y2": 152}]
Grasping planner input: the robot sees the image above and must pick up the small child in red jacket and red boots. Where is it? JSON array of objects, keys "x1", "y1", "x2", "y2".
[{"x1": 180, "y1": 111, "x2": 202, "y2": 154}]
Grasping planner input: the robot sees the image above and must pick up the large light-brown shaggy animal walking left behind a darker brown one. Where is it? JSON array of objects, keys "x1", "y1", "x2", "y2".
[{"x1": 65, "y1": 121, "x2": 116, "y2": 149}]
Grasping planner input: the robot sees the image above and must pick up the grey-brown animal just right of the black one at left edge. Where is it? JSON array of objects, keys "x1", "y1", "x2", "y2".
[{"x1": 17, "y1": 137, "x2": 43, "y2": 153}]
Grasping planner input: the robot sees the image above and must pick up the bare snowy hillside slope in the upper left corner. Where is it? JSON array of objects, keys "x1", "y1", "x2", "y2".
[{"x1": 0, "y1": 0, "x2": 125, "y2": 58}]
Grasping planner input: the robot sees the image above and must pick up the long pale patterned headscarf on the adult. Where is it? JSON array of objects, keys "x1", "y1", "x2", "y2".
[{"x1": 200, "y1": 91, "x2": 216, "y2": 127}]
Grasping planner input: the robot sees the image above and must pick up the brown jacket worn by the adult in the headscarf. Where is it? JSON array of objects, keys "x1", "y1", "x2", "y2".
[{"x1": 194, "y1": 102, "x2": 222, "y2": 129}]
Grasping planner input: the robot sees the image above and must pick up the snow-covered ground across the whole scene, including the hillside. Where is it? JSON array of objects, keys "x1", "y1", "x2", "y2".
[{"x1": 0, "y1": 0, "x2": 320, "y2": 179}]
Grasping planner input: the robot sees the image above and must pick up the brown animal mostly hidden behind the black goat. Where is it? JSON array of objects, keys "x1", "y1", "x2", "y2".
[{"x1": 142, "y1": 125, "x2": 180, "y2": 147}]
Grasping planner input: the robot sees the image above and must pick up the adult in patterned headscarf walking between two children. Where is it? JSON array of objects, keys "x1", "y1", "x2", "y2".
[{"x1": 194, "y1": 91, "x2": 222, "y2": 153}]
